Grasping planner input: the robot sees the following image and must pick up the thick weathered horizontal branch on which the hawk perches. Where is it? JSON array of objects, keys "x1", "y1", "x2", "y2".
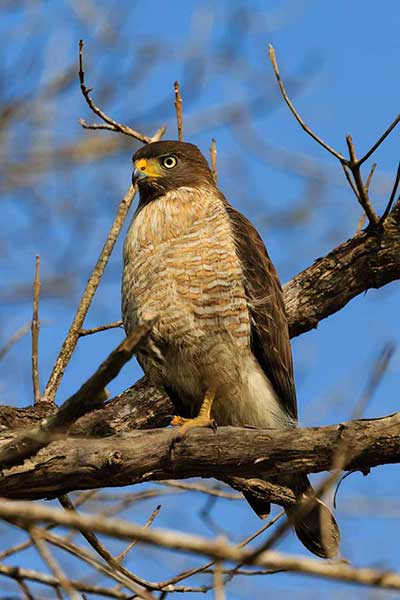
[{"x1": 0, "y1": 413, "x2": 400, "y2": 505}]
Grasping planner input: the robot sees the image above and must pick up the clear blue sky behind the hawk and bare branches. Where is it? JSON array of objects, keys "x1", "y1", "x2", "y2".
[{"x1": 0, "y1": 0, "x2": 400, "y2": 598}]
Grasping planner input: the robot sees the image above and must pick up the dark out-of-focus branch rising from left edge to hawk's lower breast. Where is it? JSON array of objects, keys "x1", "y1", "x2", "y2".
[{"x1": 0, "y1": 320, "x2": 155, "y2": 466}]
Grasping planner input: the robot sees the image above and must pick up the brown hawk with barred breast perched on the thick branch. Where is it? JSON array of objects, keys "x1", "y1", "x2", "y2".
[{"x1": 122, "y1": 141, "x2": 339, "y2": 558}]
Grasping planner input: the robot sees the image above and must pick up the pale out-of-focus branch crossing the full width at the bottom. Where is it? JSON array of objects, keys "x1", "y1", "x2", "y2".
[{"x1": 0, "y1": 500, "x2": 400, "y2": 590}]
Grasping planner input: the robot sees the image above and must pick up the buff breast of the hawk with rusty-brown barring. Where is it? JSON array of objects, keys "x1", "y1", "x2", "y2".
[{"x1": 122, "y1": 188, "x2": 250, "y2": 352}]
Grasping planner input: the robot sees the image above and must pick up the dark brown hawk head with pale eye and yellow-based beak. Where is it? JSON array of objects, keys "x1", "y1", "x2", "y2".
[{"x1": 132, "y1": 141, "x2": 215, "y2": 202}]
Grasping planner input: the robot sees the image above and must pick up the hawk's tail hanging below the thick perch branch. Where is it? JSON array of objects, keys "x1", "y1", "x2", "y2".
[{"x1": 244, "y1": 475, "x2": 340, "y2": 558}]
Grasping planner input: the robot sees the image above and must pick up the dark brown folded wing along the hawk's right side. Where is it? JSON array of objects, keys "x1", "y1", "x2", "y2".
[{"x1": 225, "y1": 200, "x2": 297, "y2": 419}]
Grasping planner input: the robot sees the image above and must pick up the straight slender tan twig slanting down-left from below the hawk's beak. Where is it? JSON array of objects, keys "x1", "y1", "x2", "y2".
[{"x1": 43, "y1": 186, "x2": 136, "y2": 402}]
